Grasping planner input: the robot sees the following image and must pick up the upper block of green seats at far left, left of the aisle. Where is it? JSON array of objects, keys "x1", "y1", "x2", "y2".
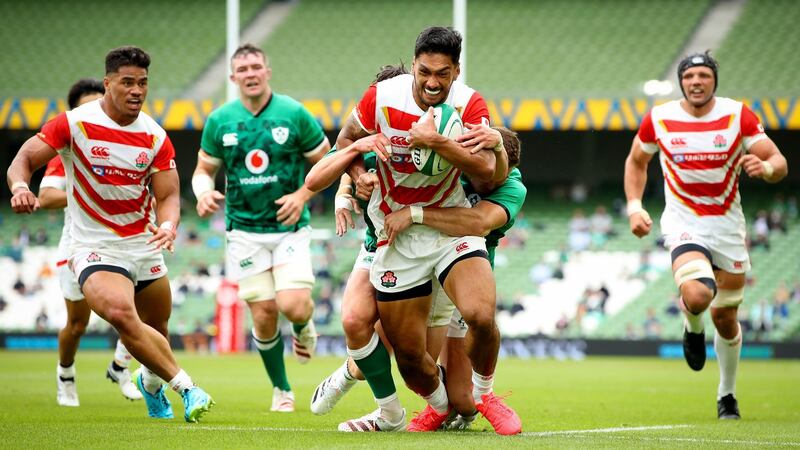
[{"x1": 0, "y1": 0, "x2": 266, "y2": 98}]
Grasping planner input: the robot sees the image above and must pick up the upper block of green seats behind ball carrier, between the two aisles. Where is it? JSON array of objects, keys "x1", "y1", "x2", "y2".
[{"x1": 264, "y1": 0, "x2": 710, "y2": 98}]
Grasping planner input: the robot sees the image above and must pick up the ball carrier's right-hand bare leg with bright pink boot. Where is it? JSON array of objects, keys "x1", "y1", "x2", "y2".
[{"x1": 442, "y1": 258, "x2": 522, "y2": 434}]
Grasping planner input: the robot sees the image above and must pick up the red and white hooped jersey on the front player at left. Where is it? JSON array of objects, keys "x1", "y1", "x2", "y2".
[{"x1": 38, "y1": 100, "x2": 175, "y2": 247}]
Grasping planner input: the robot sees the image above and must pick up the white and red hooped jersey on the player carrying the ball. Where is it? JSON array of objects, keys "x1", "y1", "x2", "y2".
[{"x1": 353, "y1": 74, "x2": 489, "y2": 244}]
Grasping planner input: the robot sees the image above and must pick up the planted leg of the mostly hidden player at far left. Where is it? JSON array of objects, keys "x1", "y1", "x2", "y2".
[{"x1": 56, "y1": 299, "x2": 92, "y2": 406}]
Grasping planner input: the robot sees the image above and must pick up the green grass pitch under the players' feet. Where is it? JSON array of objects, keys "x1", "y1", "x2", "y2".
[{"x1": 0, "y1": 351, "x2": 800, "y2": 449}]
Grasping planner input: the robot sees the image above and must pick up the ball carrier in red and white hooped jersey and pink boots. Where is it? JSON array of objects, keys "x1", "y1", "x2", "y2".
[{"x1": 318, "y1": 27, "x2": 519, "y2": 434}]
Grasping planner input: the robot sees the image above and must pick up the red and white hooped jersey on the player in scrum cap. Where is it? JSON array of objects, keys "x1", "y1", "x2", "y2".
[{"x1": 639, "y1": 97, "x2": 767, "y2": 238}]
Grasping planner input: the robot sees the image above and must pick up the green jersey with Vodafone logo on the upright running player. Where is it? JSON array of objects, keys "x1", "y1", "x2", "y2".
[{"x1": 200, "y1": 96, "x2": 325, "y2": 233}]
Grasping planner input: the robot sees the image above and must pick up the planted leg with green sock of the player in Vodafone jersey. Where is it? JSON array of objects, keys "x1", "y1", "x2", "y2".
[{"x1": 247, "y1": 299, "x2": 294, "y2": 412}]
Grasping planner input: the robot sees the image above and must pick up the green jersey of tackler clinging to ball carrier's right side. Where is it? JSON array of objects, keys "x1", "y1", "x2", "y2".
[{"x1": 461, "y1": 168, "x2": 528, "y2": 267}]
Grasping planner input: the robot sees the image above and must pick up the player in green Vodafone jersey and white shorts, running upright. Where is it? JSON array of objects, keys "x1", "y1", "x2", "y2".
[{"x1": 192, "y1": 44, "x2": 330, "y2": 412}]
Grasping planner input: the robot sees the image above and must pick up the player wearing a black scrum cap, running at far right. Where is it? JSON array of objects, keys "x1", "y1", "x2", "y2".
[{"x1": 625, "y1": 52, "x2": 788, "y2": 419}]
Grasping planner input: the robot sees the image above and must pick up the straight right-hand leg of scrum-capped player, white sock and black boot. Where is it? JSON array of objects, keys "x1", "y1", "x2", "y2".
[{"x1": 711, "y1": 270, "x2": 745, "y2": 419}]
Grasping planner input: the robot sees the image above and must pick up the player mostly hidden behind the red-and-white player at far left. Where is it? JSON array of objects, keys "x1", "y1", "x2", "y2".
[{"x1": 39, "y1": 78, "x2": 142, "y2": 406}]
